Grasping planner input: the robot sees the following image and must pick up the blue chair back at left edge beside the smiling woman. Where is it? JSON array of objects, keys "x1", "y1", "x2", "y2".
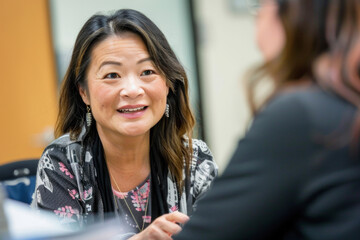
[{"x1": 0, "y1": 159, "x2": 39, "y2": 204}]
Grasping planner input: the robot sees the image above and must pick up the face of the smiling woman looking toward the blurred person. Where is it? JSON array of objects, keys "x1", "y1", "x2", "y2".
[{"x1": 79, "y1": 32, "x2": 169, "y2": 140}]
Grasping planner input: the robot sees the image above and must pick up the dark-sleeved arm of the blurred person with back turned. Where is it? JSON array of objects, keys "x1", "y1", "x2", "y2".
[{"x1": 174, "y1": 94, "x2": 311, "y2": 240}]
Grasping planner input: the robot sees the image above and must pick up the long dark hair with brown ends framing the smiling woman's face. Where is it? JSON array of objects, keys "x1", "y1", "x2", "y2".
[{"x1": 55, "y1": 9, "x2": 195, "y2": 190}]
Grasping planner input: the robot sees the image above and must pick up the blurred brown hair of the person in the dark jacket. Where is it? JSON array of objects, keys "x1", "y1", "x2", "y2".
[{"x1": 247, "y1": 0, "x2": 360, "y2": 114}]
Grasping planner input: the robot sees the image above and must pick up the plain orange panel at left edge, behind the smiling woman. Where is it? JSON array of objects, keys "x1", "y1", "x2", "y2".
[{"x1": 0, "y1": 0, "x2": 57, "y2": 164}]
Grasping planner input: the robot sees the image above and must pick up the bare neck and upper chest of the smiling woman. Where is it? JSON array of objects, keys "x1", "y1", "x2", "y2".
[{"x1": 99, "y1": 127, "x2": 150, "y2": 192}]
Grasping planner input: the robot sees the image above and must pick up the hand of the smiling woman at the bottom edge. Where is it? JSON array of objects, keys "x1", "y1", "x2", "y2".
[{"x1": 129, "y1": 212, "x2": 189, "y2": 240}]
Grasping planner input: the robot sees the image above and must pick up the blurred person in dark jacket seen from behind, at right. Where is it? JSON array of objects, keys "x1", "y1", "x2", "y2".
[{"x1": 173, "y1": 0, "x2": 360, "y2": 240}]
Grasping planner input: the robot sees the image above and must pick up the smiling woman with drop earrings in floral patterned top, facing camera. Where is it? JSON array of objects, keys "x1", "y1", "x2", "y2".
[{"x1": 32, "y1": 9, "x2": 217, "y2": 239}]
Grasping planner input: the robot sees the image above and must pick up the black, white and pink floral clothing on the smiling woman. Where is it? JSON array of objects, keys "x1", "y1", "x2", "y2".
[{"x1": 32, "y1": 134, "x2": 218, "y2": 236}]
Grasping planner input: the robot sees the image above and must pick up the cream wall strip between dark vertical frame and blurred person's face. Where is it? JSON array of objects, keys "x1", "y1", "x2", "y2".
[{"x1": 195, "y1": 0, "x2": 261, "y2": 170}]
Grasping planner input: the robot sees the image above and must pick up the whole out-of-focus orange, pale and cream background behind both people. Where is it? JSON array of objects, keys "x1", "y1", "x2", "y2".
[{"x1": 0, "y1": 0, "x2": 261, "y2": 171}]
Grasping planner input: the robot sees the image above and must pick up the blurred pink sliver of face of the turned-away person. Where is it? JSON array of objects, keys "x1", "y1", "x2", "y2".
[{"x1": 256, "y1": 0, "x2": 285, "y2": 61}]
